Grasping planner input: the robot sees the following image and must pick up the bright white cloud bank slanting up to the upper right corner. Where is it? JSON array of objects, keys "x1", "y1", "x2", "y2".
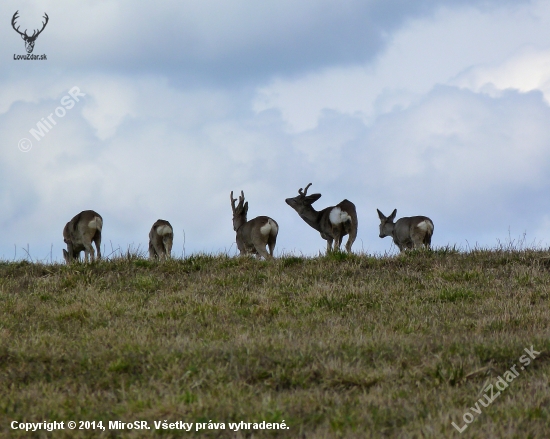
[{"x1": 254, "y1": 1, "x2": 550, "y2": 132}]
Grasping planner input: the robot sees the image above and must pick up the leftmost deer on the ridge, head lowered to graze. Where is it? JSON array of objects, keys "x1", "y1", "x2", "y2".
[{"x1": 63, "y1": 210, "x2": 103, "y2": 264}]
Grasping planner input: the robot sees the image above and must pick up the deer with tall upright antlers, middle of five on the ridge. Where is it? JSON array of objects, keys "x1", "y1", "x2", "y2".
[{"x1": 230, "y1": 191, "x2": 279, "y2": 259}]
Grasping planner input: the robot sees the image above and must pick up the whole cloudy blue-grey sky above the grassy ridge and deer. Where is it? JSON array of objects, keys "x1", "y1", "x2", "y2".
[{"x1": 0, "y1": 0, "x2": 550, "y2": 261}]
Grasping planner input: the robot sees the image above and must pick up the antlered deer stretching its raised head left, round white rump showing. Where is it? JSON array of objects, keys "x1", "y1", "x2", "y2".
[{"x1": 285, "y1": 183, "x2": 357, "y2": 253}]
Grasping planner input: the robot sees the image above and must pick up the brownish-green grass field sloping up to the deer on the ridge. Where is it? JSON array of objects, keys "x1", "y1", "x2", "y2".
[{"x1": 0, "y1": 248, "x2": 550, "y2": 439}]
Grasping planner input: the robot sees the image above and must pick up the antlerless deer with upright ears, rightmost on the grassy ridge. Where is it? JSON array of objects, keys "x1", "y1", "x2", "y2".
[{"x1": 376, "y1": 209, "x2": 434, "y2": 251}]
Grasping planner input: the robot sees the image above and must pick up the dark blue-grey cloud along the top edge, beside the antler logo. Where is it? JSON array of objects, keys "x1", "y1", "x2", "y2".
[{"x1": 0, "y1": 0, "x2": 528, "y2": 86}]
